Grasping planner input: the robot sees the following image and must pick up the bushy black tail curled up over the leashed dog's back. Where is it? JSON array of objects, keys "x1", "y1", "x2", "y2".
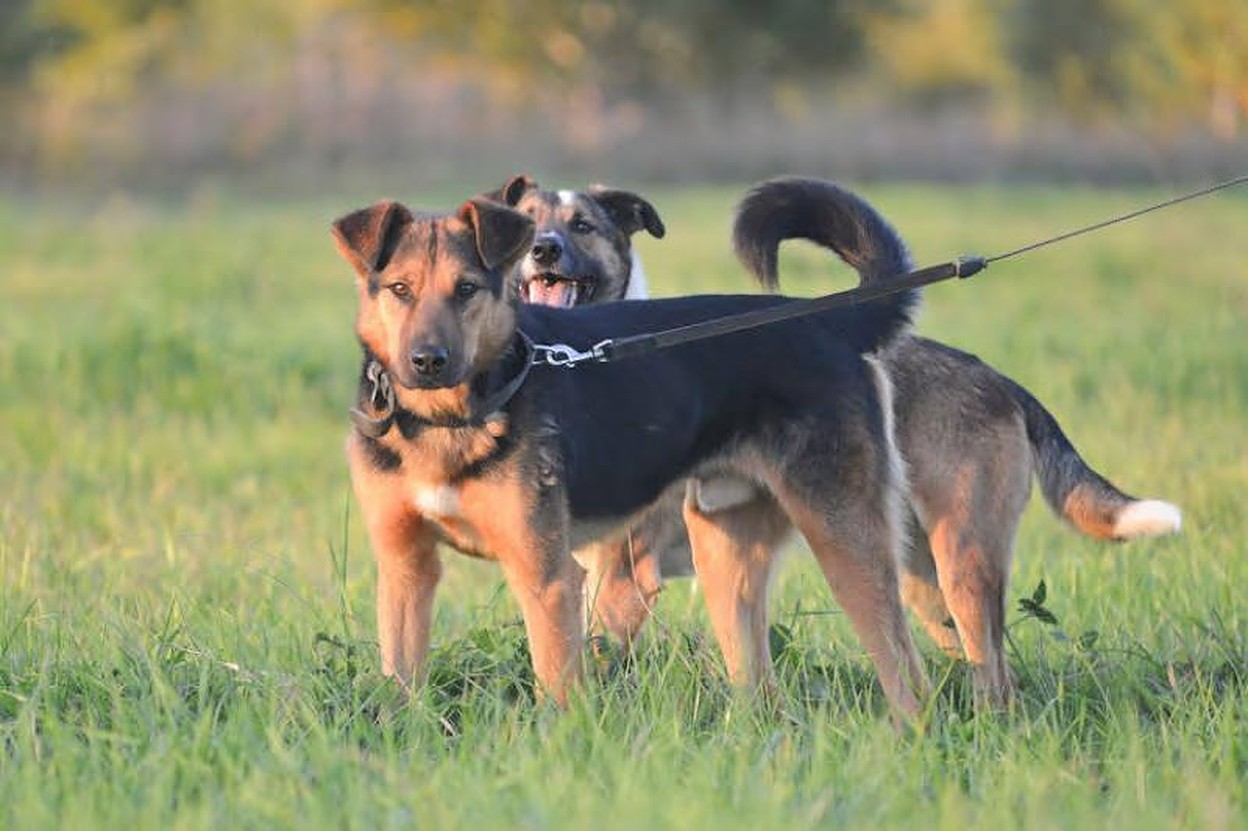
[{"x1": 733, "y1": 177, "x2": 920, "y2": 348}]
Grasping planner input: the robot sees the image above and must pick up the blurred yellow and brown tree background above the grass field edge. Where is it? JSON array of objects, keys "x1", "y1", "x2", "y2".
[{"x1": 0, "y1": 0, "x2": 1248, "y2": 187}]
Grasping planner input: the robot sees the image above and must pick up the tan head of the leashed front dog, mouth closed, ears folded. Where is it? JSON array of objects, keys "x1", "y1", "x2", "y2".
[{"x1": 333, "y1": 198, "x2": 533, "y2": 389}]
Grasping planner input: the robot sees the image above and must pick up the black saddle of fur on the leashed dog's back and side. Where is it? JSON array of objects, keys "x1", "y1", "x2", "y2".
[{"x1": 515, "y1": 286, "x2": 914, "y2": 519}]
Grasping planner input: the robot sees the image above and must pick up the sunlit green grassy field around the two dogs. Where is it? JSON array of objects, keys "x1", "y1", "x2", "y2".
[{"x1": 0, "y1": 182, "x2": 1248, "y2": 831}]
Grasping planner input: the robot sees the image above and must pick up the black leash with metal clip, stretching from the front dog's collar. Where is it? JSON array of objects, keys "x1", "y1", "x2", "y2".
[{"x1": 533, "y1": 173, "x2": 1248, "y2": 367}]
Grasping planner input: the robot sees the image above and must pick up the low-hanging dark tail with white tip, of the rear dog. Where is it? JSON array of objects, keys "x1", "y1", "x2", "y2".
[{"x1": 1002, "y1": 376, "x2": 1183, "y2": 540}]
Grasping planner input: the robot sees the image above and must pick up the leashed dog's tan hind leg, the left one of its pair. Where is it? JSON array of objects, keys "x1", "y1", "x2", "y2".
[{"x1": 684, "y1": 480, "x2": 789, "y2": 690}]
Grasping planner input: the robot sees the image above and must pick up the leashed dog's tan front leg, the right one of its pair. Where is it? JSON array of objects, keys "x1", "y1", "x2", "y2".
[{"x1": 500, "y1": 539, "x2": 584, "y2": 706}]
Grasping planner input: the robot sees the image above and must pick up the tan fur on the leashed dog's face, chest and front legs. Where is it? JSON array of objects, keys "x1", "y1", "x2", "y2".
[{"x1": 338, "y1": 199, "x2": 583, "y2": 704}]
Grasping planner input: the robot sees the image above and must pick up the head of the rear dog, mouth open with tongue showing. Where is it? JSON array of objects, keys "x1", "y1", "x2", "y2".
[{"x1": 487, "y1": 175, "x2": 665, "y2": 307}]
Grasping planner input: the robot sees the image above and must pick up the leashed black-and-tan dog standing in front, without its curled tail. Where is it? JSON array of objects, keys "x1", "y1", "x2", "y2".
[{"x1": 333, "y1": 190, "x2": 926, "y2": 715}]
